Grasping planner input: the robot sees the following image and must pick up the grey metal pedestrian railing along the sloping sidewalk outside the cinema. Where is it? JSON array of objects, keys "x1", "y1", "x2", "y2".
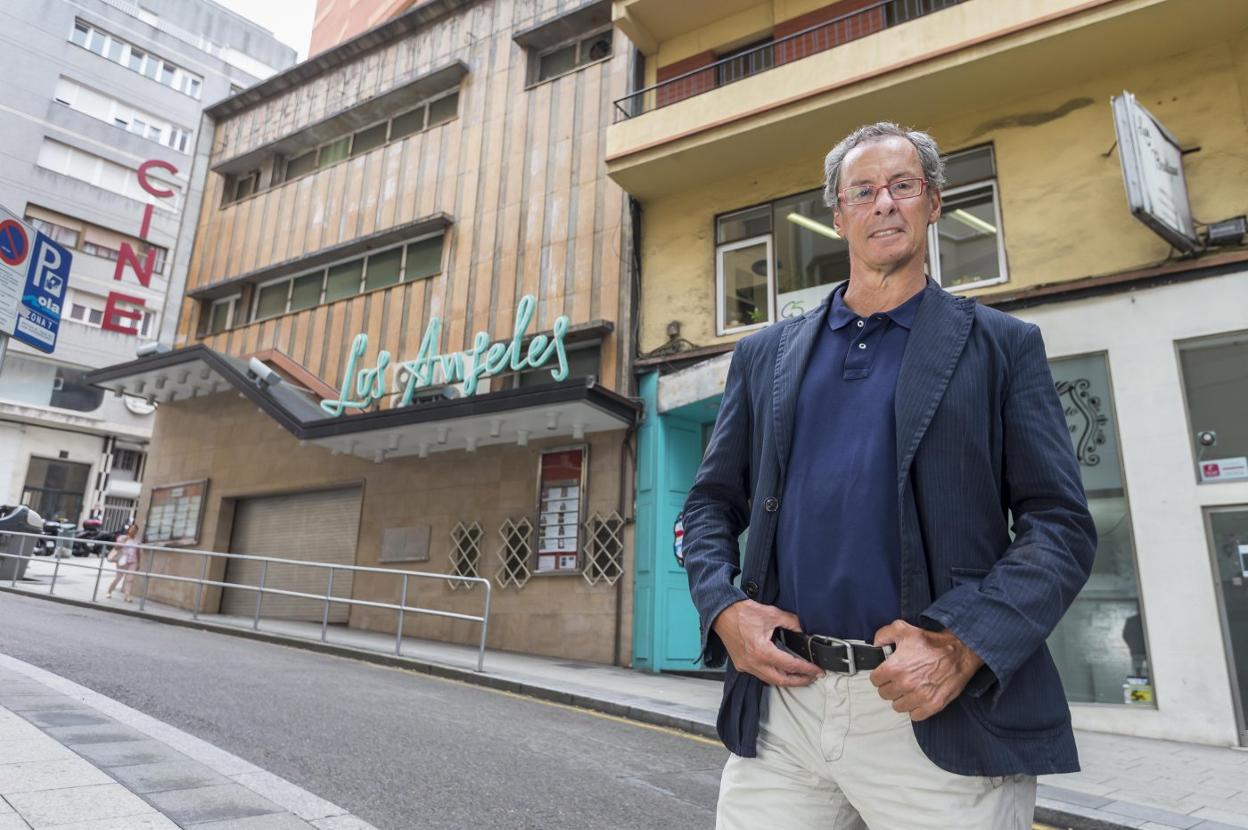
[{"x1": 0, "y1": 532, "x2": 492, "y2": 671}]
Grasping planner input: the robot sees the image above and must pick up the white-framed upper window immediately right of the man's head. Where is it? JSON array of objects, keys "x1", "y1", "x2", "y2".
[{"x1": 927, "y1": 147, "x2": 1007, "y2": 288}]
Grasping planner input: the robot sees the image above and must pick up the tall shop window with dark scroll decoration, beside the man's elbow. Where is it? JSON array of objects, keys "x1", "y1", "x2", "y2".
[{"x1": 1048, "y1": 354, "x2": 1153, "y2": 705}]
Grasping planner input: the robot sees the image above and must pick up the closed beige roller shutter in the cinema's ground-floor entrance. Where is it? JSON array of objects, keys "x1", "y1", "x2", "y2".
[{"x1": 221, "y1": 488, "x2": 359, "y2": 623}]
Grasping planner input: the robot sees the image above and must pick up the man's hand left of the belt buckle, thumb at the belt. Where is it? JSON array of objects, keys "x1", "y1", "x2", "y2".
[{"x1": 711, "y1": 599, "x2": 822, "y2": 686}]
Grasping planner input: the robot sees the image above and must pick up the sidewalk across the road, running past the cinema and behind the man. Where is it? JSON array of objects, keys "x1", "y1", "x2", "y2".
[{"x1": 9, "y1": 559, "x2": 1248, "y2": 830}]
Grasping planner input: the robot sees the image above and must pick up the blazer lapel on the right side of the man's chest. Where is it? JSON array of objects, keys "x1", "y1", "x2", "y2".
[{"x1": 895, "y1": 278, "x2": 975, "y2": 492}]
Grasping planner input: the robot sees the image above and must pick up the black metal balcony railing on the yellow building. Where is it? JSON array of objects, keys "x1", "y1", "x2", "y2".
[{"x1": 615, "y1": 0, "x2": 966, "y2": 121}]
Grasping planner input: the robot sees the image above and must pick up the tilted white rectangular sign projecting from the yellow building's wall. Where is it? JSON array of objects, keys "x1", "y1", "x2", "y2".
[{"x1": 1109, "y1": 91, "x2": 1201, "y2": 253}]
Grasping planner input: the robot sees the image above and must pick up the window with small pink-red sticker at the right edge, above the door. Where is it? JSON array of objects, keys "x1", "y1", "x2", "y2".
[{"x1": 1178, "y1": 331, "x2": 1248, "y2": 484}]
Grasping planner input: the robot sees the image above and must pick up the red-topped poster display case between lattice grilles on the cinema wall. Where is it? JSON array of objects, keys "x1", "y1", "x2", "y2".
[{"x1": 534, "y1": 447, "x2": 587, "y2": 574}]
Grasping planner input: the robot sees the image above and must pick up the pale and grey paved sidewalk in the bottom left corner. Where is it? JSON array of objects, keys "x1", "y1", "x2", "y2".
[{"x1": 0, "y1": 655, "x2": 371, "y2": 830}]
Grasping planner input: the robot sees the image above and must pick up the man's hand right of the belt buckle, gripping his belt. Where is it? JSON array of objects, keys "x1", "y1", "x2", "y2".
[{"x1": 871, "y1": 619, "x2": 983, "y2": 720}]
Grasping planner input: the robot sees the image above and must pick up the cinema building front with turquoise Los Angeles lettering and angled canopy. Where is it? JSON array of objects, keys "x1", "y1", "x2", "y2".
[{"x1": 90, "y1": 0, "x2": 640, "y2": 665}]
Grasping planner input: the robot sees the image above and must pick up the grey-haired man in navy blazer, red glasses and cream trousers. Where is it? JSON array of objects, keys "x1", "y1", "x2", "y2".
[{"x1": 684, "y1": 122, "x2": 1096, "y2": 830}]
